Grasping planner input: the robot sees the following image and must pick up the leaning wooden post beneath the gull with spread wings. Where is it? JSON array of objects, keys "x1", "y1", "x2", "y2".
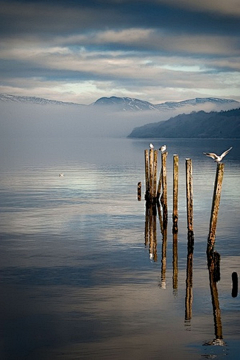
[{"x1": 207, "y1": 163, "x2": 224, "y2": 252}]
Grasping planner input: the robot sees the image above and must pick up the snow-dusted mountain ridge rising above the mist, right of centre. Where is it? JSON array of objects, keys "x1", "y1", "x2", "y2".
[{"x1": 91, "y1": 96, "x2": 240, "y2": 111}]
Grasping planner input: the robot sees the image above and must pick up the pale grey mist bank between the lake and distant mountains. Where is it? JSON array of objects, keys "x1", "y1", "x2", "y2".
[{"x1": 0, "y1": 102, "x2": 237, "y2": 139}]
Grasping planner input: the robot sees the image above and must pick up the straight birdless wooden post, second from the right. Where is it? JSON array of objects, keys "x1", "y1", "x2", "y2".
[{"x1": 186, "y1": 159, "x2": 193, "y2": 233}]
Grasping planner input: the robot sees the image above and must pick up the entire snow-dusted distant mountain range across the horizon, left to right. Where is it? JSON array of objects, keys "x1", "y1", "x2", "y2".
[{"x1": 0, "y1": 94, "x2": 240, "y2": 113}]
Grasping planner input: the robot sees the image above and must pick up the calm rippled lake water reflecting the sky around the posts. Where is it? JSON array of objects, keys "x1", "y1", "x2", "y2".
[{"x1": 0, "y1": 139, "x2": 240, "y2": 360}]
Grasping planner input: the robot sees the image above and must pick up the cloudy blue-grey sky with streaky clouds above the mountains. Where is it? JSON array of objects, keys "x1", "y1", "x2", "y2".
[{"x1": 0, "y1": 0, "x2": 240, "y2": 104}]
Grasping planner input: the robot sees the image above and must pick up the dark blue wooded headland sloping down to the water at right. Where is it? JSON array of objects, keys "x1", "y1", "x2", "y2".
[{"x1": 128, "y1": 108, "x2": 240, "y2": 138}]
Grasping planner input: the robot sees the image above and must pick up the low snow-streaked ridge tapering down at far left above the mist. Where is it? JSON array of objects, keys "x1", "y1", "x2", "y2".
[{"x1": 0, "y1": 94, "x2": 85, "y2": 106}]
